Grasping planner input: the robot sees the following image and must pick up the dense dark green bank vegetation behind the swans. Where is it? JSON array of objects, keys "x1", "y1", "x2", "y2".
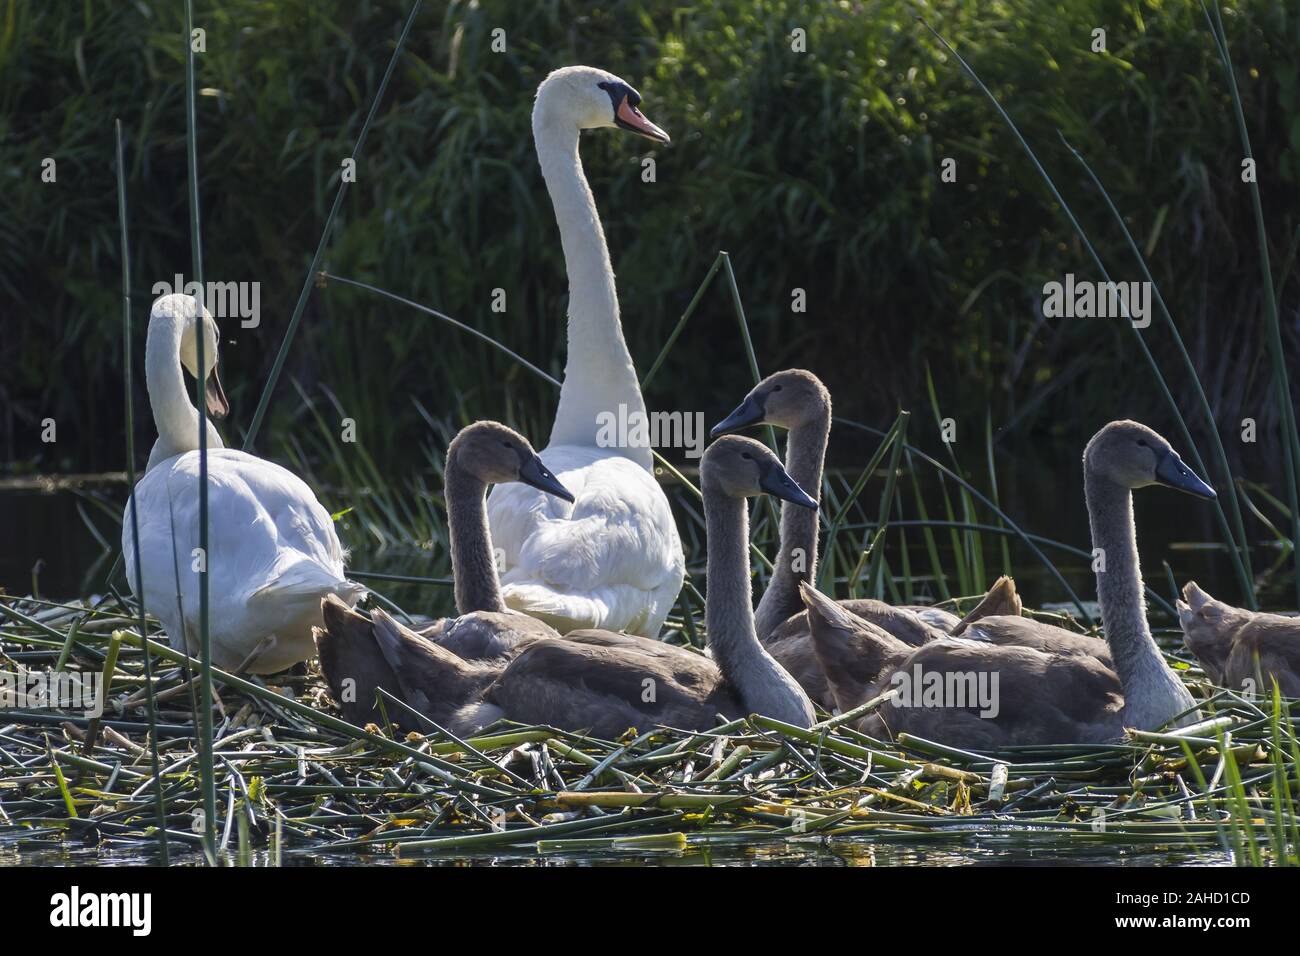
[{"x1": 0, "y1": 0, "x2": 1300, "y2": 473}]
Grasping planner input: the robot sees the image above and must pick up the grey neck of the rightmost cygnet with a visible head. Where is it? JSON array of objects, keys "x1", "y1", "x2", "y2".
[{"x1": 1083, "y1": 464, "x2": 1192, "y2": 730}]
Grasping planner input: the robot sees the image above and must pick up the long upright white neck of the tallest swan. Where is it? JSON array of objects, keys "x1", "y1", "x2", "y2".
[{"x1": 533, "y1": 111, "x2": 653, "y2": 470}]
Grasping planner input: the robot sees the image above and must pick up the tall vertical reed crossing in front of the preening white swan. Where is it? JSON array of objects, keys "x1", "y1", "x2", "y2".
[{"x1": 177, "y1": 0, "x2": 217, "y2": 864}]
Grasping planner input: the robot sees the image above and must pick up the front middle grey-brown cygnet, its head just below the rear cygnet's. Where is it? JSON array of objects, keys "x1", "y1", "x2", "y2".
[{"x1": 463, "y1": 436, "x2": 815, "y2": 737}]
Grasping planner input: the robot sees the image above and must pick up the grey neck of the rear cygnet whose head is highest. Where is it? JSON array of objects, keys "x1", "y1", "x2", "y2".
[{"x1": 754, "y1": 408, "x2": 831, "y2": 641}]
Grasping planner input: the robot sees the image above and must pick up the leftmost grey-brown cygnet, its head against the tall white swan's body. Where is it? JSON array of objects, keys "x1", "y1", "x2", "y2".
[{"x1": 316, "y1": 421, "x2": 568, "y2": 730}]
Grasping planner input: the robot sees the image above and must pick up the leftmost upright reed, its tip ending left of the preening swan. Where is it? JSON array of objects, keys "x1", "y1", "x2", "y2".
[{"x1": 116, "y1": 120, "x2": 169, "y2": 866}]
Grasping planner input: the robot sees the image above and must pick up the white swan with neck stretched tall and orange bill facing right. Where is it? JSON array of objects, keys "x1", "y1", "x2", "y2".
[{"x1": 488, "y1": 66, "x2": 685, "y2": 637}]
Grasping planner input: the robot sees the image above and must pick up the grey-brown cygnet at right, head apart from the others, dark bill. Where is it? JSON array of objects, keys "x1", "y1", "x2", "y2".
[{"x1": 803, "y1": 421, "x2": 1213, "y2": 748}]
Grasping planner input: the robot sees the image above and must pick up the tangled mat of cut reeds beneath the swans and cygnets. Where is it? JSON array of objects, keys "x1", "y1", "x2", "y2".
[{"x1": 0, "y1": 596, "x2": 1300, "y2": 862}]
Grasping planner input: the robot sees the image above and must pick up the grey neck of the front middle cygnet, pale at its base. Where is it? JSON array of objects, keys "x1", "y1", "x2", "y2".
[{"x1": 703, "y1": 477, "x2": 813, "y2": 727}]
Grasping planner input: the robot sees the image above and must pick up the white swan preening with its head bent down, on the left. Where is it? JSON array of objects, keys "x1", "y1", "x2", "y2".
[{"x1": 122, "y1": 295, "x2": 364, "y2": 674}]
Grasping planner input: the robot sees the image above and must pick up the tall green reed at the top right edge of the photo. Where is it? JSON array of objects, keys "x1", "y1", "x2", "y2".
[{"x1": 1201, "y1": 0, "x2": 1300, "y2": 602}]
